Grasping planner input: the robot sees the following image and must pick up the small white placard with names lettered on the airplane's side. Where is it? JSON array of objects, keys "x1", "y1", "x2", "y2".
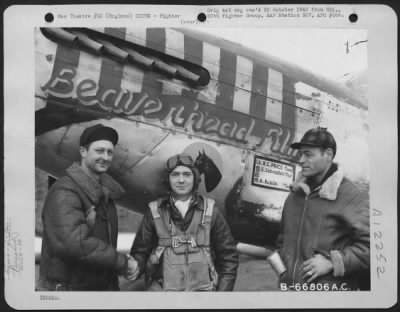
[{"x1": 251, "y1": 156, "x2": 295, "y2": 192}]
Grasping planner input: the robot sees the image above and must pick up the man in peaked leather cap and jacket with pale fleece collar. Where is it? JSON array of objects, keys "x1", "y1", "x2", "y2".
[{"x1": 278, "y1": 128, "x2": 370, "y2": 290}]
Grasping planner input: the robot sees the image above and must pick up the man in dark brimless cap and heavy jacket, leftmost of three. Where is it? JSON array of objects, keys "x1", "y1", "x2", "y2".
[{"x1": 37, "y1": 124, "x2": 137, "y2": 291}]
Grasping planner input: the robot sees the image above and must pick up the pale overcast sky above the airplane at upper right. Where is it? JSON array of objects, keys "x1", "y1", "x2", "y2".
[{"x1": 201, "y1": 28, "x2": 368, "y2": 80}]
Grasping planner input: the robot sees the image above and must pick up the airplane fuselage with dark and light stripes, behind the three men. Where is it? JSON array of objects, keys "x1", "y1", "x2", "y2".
[{"x1": 35, "y1": 28, "x2": 369, "y2": 245}]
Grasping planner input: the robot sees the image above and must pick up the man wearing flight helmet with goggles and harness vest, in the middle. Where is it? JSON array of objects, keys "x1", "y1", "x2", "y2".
[{"x1": 131, "y1": 154, "x2": 238, "y2": 291}]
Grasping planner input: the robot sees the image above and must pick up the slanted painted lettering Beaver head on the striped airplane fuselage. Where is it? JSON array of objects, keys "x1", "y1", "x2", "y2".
[{"x1": 41, "y1": 67, "x2": 294, "y2": 156}]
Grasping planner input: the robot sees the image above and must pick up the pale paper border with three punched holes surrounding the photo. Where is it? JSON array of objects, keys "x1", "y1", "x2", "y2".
[{"x1": 4, "y1": 4, "x2": 398, "y2": 310}]
